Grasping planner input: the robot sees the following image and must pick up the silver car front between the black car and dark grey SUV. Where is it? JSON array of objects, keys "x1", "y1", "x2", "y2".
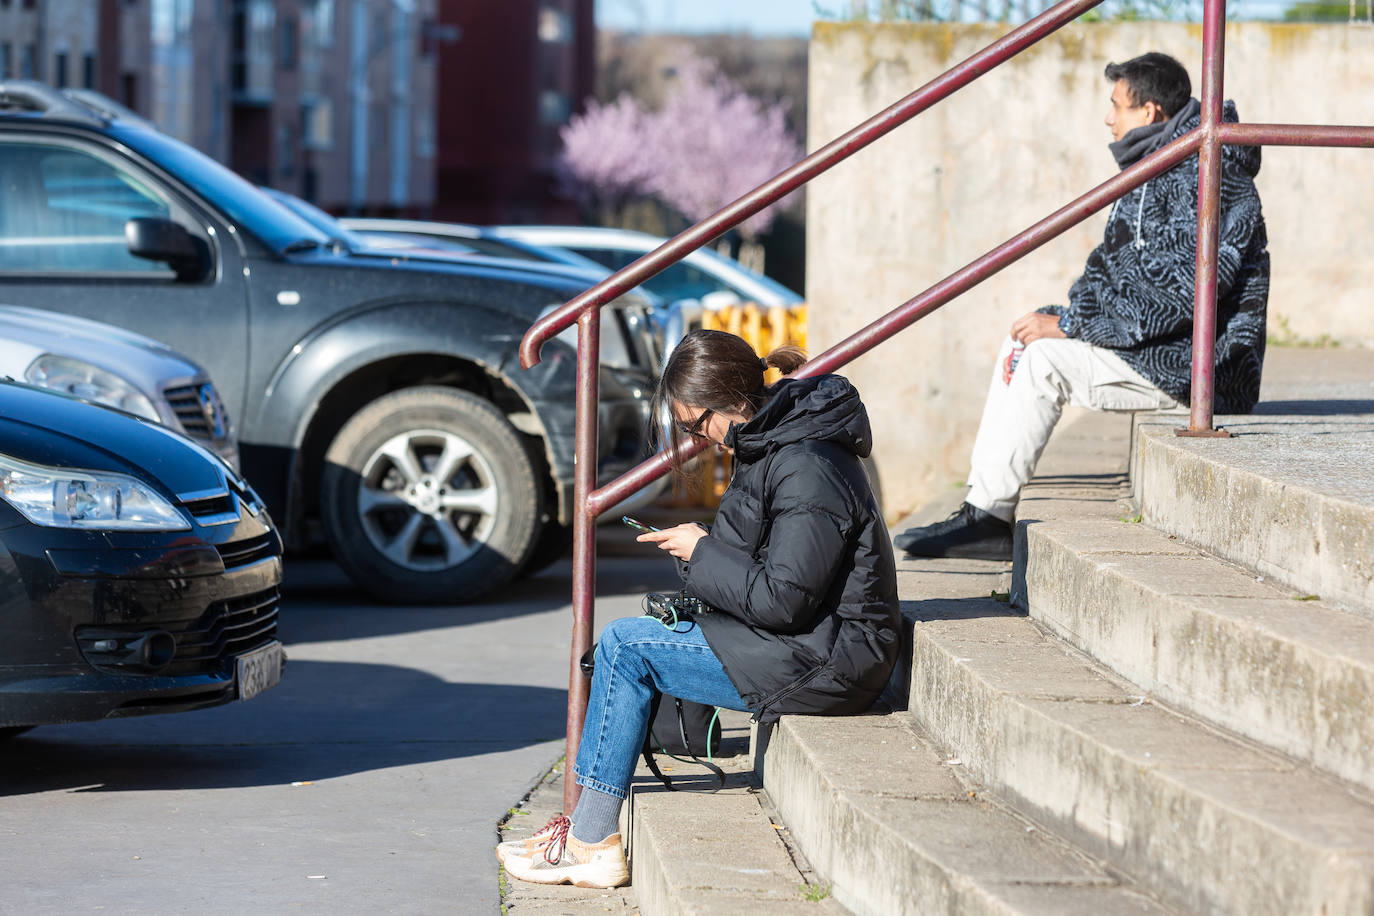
[{"x1": 0, "y1": 305, "x2": 239, "y2": 471}]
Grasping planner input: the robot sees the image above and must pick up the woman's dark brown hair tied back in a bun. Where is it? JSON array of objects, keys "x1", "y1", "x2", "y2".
[{"x1": 649, "y1": 330, "x2": 807, "y2": 474}]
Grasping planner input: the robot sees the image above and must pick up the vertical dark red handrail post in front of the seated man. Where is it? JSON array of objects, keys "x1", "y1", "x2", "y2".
[{"x1": 1176, "y1": 0, "x2": 1230, "y2": 437}]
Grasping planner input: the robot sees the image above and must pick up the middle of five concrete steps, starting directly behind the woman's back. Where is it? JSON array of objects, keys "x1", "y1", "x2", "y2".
[{"x1": 911, "y1": 599, "x2": 1374, "y2": 916}]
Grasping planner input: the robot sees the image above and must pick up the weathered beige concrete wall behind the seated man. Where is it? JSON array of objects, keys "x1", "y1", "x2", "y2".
[{"x1": 807, "y1": 23, "x2": 1374, "y2": 519}]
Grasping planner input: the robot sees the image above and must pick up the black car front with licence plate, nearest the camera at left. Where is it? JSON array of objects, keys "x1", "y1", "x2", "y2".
[{"x1": 0, "y1": 382, "x2": 283, "y2": 736}]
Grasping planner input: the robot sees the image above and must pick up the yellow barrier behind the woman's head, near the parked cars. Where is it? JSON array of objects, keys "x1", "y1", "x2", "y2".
[{"x1": 662, "y1": 302, "x2": 807, "y2": 508}]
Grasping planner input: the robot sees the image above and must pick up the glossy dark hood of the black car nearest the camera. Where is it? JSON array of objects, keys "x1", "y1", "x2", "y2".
[{"x1": 0, "y1": 382, "x2": 232, "y2": 496}]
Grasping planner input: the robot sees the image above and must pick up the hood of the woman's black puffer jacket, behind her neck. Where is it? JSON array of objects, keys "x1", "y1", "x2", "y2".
[{"x1": 725, "y1": 375, "x2": 872, "y2": 461}]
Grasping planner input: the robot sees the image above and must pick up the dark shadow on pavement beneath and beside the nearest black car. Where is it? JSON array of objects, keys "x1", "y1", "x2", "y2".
[{"x1": 0, "y1": 661, "x2": 567, "y2": 795}]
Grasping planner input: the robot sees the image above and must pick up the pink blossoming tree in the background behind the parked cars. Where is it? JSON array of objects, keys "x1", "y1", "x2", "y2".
[{"x1": 562, "y1": 54, "x2": 802, "y2": 269}]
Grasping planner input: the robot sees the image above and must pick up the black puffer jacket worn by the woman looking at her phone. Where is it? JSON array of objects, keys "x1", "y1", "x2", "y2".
[{"x1": 684, "y1": 375, "x2": 900, "y2": 721}]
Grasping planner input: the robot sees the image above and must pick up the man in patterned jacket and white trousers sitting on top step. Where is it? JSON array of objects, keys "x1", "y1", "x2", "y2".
[{"x1": 894, "y1": 52, "x2": 1270, "y2": 560}]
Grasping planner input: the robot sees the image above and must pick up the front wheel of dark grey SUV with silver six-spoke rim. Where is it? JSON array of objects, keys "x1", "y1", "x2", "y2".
[{"x1": 320, "y1": 387, "x2": 541, "y2": 604}]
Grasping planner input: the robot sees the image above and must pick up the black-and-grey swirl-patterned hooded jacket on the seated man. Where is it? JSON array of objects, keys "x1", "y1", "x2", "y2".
[{"x1": 1047, "y1": 99, "x2": 1270, "y2": 413}]
